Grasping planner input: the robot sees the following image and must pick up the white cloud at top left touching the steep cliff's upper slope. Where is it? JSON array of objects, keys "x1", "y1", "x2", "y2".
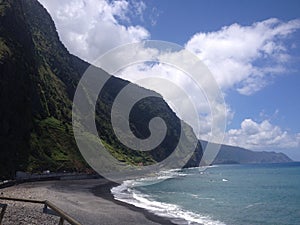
[{"x1": 39, "y1": 0, "x2": 150, "y2": 62}]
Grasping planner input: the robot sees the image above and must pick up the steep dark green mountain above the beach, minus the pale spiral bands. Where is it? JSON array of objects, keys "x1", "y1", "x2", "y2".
[{"x1": 0, "y1": 0, "x2": 202, "y2": 178}]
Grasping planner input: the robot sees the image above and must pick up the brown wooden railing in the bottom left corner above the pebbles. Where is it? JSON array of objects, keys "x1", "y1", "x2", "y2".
[{"x1": 0, "y1": 196, "x2": 82, "y2": 225}]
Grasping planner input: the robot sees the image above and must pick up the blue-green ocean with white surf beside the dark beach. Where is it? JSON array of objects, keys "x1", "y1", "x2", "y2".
[{"x1": 111, "y1": 162, "x2": 300, "y2": 225}]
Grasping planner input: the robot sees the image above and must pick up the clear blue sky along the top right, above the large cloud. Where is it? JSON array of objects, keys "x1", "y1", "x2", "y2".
[{"x1": 146, "y1": 0, "x2": 300, "y2": 42}]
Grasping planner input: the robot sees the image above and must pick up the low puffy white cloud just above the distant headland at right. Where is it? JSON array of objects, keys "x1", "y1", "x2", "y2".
[{"x1": 224, "y1": 119, "x2": 300, "y2": 150}]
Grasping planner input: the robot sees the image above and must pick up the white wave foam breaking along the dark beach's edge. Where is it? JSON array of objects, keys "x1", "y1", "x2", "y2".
[{"x1": 111, "y1": 171, "x2": 225, "y2": 225}]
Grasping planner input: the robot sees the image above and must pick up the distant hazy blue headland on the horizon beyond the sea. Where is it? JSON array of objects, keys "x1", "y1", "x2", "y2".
[{"x1": 201, "y1": 141, "x2": 293, "y2": 164}]
